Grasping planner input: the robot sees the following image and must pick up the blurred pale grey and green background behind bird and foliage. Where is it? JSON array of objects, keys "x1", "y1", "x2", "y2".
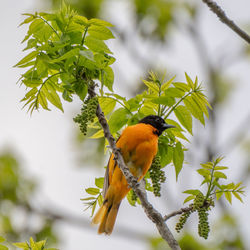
[{"x1": 0, "y1": 0, "x2": 250, "y2": 250}]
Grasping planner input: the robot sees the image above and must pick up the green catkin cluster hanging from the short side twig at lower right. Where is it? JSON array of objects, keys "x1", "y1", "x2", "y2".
[{"x1": 175, "y1": 192, "x2": 214, "y2": 239}]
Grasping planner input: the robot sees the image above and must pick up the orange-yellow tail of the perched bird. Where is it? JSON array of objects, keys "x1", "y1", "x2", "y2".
[{"x1": 92, "y1": 190, "x2": 121, "y2": 235}]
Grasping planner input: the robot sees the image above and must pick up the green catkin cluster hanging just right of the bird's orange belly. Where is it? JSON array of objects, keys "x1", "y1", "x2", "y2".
[{"x1": 149, "y1": 155, "x2": 166, "y2": 197}]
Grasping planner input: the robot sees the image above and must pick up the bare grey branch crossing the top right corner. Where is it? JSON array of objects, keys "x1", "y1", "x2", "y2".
[{"x1": 202, "y1": 0, "x2": 250, "y2": 44}]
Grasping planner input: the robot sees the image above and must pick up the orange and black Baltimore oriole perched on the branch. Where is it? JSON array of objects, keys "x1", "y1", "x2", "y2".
[{"x1": 92, "y1": 115, "x2": 174, "y2": 234}]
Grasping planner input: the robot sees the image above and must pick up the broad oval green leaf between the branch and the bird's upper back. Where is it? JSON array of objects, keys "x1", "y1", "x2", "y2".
[{"x1": 109, "y1": 108, "x2": 129, "y2": 133}]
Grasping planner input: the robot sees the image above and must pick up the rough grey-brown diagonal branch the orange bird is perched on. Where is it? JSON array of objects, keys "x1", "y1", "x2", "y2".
[{"x1": 88, "y1": 80, "x2": 180, "y2": 250}]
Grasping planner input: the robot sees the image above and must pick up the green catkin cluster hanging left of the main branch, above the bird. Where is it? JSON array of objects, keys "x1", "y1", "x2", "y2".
[{"x1": 73, "y1": 97, "x2": 98, "y2": 135}]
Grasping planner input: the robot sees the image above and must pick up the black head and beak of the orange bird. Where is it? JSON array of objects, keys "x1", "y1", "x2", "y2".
[{"x1": 139, "y1": 115, "x2": 175, "y2": 136}]
